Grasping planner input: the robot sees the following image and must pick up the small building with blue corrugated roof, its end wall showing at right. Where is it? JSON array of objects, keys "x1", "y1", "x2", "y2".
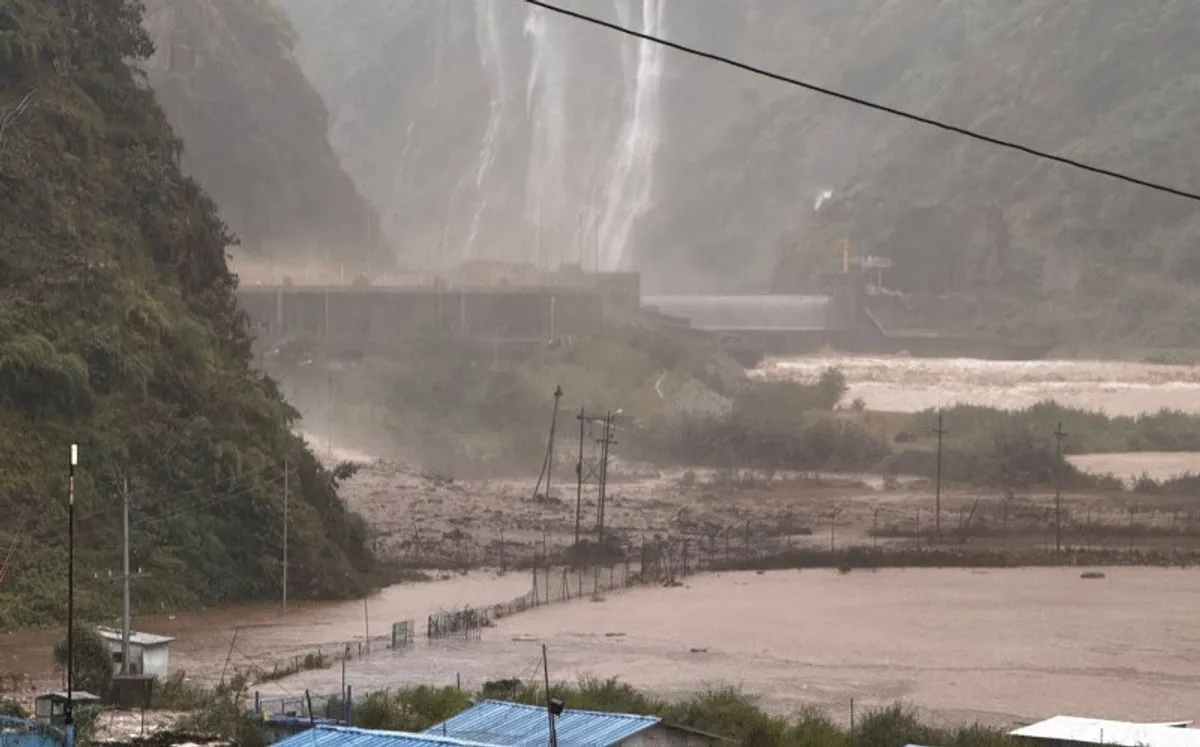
[{"x1": 425, "y1": 700, "x2": 722, "y2": 747}]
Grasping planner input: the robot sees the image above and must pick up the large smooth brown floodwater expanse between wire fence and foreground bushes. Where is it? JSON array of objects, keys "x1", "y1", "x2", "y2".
[{"x1": 276, "y1": 568, "x2": 1200, "y2": 725}]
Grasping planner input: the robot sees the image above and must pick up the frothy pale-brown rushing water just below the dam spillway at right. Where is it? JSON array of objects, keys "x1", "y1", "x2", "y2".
[{"x1": 755, "y1": 355, "x2": 1200, "y2": 416}]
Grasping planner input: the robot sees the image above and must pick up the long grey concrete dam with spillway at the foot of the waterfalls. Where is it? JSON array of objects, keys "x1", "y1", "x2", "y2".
[{"x1": 238, "y1": 281, "x2": 1049, "y2": 360}]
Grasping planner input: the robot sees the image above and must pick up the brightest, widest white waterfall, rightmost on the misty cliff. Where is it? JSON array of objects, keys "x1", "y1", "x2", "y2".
[{"x1": 598, "y1": 0, "x2": 665, "y2": 271}]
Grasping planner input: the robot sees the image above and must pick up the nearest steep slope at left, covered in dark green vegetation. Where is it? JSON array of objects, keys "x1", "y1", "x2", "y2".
[{"x1": 0, "y1": 0, "x2": 372, "y2": 629}]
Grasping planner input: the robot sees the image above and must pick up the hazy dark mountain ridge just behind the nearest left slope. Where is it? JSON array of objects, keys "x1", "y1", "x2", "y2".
[{"x1": 145, "y1": 0, "x2": 391, "y2": 269}]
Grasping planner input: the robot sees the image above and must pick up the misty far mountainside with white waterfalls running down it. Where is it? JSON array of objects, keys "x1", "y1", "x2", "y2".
[{"x1": 275, "y1": 0, "x2": 1200, "y2": 345}]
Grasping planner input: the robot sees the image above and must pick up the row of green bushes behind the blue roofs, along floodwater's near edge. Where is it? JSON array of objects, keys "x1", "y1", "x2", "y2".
[{"x1": 187, "y1": 680, "x2": 1014, "y2": 747}]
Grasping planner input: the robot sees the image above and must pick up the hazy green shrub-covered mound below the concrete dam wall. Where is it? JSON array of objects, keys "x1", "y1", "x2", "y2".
[{"x1": 280, "y1": 325, "x2": 889, "y2": 476}]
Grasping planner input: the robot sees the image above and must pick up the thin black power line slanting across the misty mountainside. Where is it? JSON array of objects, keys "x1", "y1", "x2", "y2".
[{"x1": 524, "y1": 0, "x2": 1200, "y2": 202}]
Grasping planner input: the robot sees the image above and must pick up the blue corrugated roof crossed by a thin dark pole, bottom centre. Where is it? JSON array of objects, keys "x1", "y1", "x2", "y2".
[{"x1": 425, "y1": 700, "x2": 661, "y2": 747}]
